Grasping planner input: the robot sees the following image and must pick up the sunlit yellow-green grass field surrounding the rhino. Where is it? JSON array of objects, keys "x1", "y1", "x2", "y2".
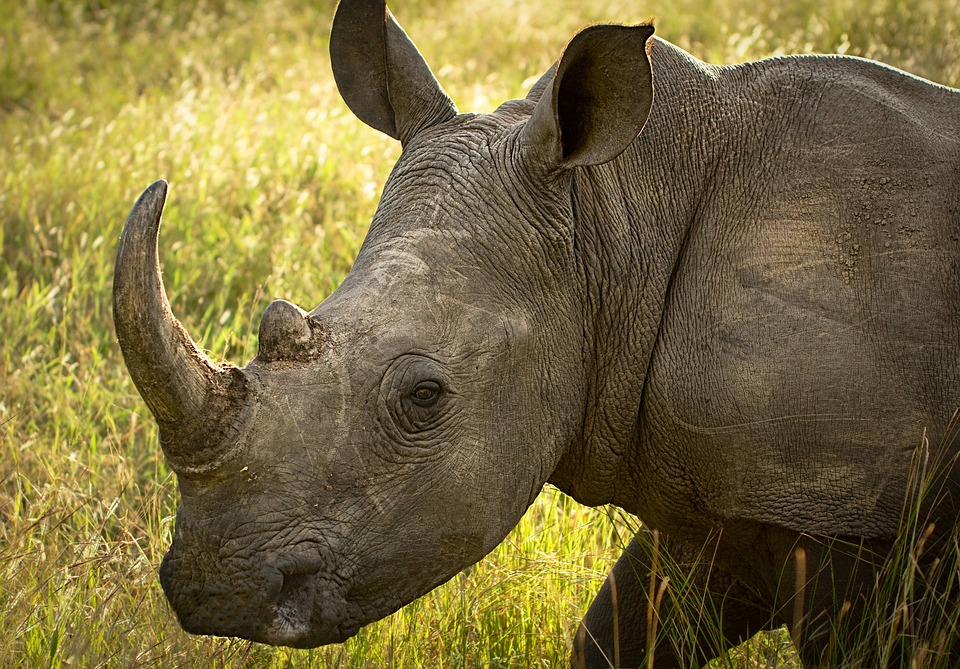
[{"x1": 0, "y1": 0, "x2": 960, "y2": 667}]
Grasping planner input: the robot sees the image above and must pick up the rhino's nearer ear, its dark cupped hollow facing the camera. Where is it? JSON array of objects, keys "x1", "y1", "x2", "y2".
[{"x1": 522, "y1": 25, "x2": 653, "y2": 169}]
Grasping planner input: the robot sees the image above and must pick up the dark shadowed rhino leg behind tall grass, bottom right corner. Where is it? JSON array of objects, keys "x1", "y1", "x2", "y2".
[{"x1": 778, "y1": 536, "x2": 960, "y2": 669}]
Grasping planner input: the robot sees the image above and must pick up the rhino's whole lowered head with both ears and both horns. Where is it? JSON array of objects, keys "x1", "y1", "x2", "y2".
[{"x1": 114, "y1": 0, "x2": 652, "y2": 647}]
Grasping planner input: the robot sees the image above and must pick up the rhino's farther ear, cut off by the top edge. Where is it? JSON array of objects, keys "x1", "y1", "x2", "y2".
[{"x1": 330, "y1": 0, "x2": 457, "y2": 143}]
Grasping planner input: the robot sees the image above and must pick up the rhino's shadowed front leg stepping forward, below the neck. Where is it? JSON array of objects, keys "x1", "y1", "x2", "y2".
[{"x1": 571, "y1": 531, "x2": 771, "y2": 669}]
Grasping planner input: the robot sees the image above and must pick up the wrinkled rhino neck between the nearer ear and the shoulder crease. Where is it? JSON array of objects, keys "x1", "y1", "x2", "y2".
[{"x1": 550, "y1": 40, "x2": 722, "y2": 513}]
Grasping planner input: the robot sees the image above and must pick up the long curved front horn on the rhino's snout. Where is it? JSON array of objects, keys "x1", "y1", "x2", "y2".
[{"x1": 113, "y1": 180, "x2": 243, "y2": 460}]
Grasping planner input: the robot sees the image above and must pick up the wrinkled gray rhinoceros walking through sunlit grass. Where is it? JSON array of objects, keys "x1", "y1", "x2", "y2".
[{"x1": 114, "y1": 0, "x2": 960, "y2": 667}]
